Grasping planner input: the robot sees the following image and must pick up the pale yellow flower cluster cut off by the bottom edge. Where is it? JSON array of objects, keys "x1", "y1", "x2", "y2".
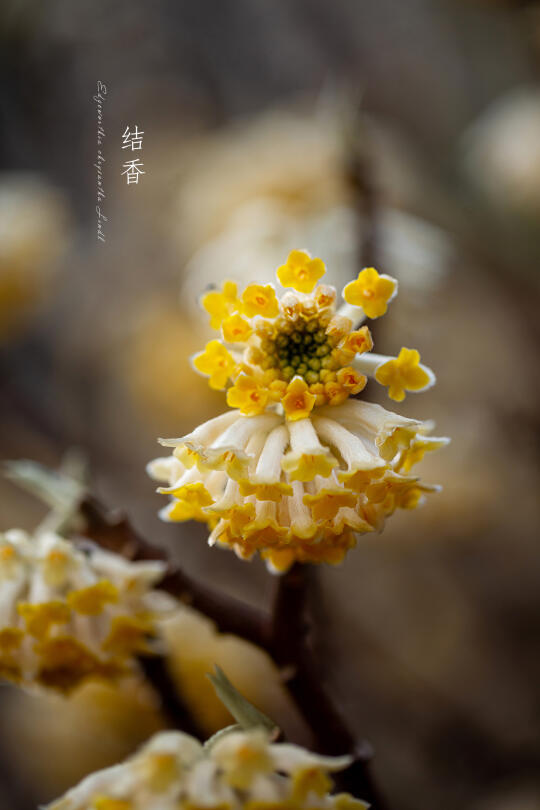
[{"x1": 48, "y1": 729, "x2": 367, "y2": 810}]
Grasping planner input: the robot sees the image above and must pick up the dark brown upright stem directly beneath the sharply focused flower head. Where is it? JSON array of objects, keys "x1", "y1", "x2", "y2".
[{"x1": 267, "y1": 563, "x2": 385, "y2": 810}]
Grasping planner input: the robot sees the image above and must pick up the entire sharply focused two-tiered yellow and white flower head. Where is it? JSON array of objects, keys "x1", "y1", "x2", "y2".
[{"x1": 149, "y1": 251, "x2": 447, "y2": 571}]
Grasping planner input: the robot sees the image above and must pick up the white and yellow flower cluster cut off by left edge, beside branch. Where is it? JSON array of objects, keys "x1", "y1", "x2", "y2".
[{"x1": 0, "y1": 530, "x2": 170, "y2": 691}]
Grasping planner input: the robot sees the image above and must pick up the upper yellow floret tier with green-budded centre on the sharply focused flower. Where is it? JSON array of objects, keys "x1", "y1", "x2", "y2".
[{"x1": 196, "y1": 250, "x2": 432, "y2": 420}]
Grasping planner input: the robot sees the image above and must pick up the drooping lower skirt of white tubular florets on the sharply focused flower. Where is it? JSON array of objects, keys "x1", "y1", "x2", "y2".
[{"x1": 148, "y1": 400, "x2": 448, "y2": 571}]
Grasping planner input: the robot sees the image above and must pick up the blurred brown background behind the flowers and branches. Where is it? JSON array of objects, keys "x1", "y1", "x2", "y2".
[{"x1": 0, "y1": 0, "x2": 540, "y2": 810}]
